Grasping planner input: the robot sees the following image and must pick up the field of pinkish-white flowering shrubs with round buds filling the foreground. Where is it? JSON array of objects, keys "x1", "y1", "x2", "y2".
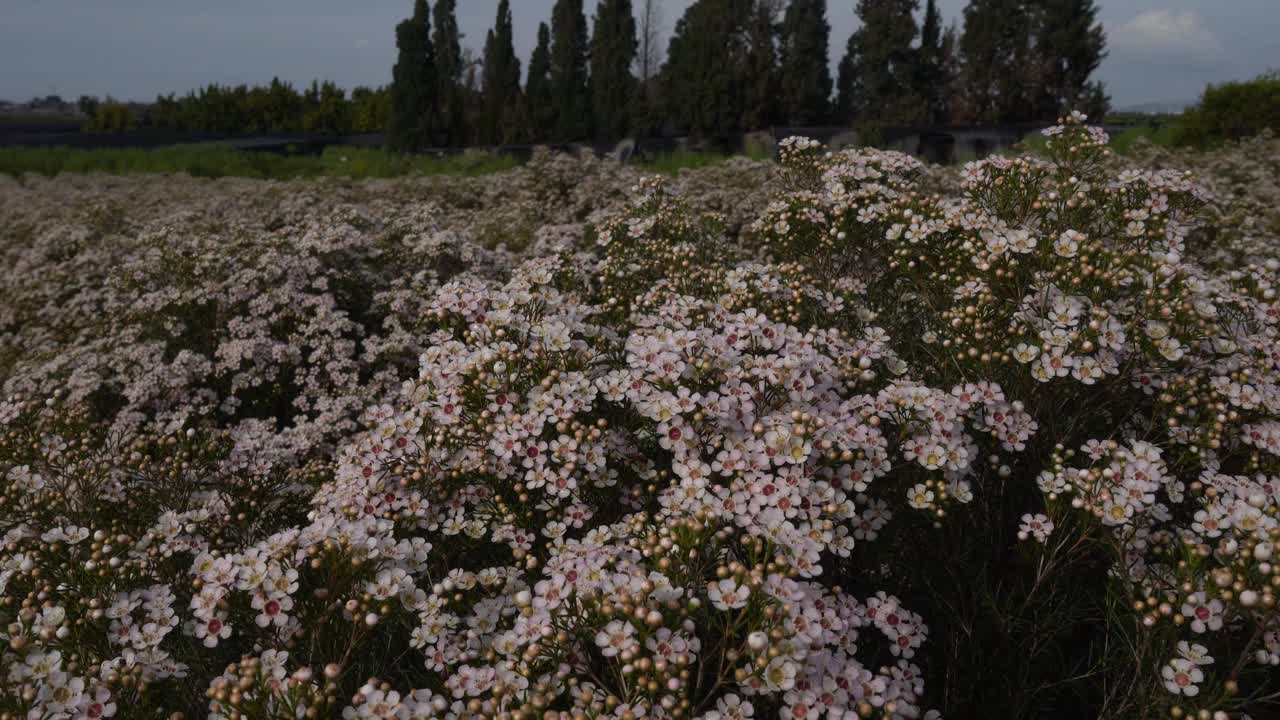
[{"x1": 0, "y1": 118, "x2": 1280, "y2": 720}]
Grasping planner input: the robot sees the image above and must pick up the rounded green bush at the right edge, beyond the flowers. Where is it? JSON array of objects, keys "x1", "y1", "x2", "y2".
[{"x1": 1174, "y1": 70, "x2": 1280, "y2": 147}]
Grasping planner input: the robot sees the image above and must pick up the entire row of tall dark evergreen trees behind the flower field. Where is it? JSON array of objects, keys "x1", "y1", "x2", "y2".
[{"x1": 388, "y1": 0, "x2": 1108, "y2": 150}]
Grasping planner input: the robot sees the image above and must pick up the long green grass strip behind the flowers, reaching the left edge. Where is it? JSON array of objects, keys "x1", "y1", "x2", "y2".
[{"x1": 0, "y1": 143, "x2": 518, "y2": 179}]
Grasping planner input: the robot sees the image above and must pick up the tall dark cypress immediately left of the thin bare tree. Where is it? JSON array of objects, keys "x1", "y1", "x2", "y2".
[{"x1": 590, "y1": 0, "x2": 639, "y2": 140}]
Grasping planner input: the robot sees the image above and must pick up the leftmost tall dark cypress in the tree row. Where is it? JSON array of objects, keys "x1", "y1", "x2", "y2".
[{"x1": 387, "y1": 0, "x2": 436, "y2": 151}]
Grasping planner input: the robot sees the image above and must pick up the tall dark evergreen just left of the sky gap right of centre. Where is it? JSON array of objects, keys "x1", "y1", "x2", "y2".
[{"x1": 778, "y1": 0, "x2": 831, "y2": 126}]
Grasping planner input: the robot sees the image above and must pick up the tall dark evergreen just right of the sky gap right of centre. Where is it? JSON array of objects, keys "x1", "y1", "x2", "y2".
[{"x1": 856, "y1": 0, "x2": 925, "y2": 124}]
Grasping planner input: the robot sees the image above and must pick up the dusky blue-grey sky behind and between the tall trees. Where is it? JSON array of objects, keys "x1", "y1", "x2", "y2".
[{"x1": 0, "y1": 0, "x2": 1280, "y2": 108}]
